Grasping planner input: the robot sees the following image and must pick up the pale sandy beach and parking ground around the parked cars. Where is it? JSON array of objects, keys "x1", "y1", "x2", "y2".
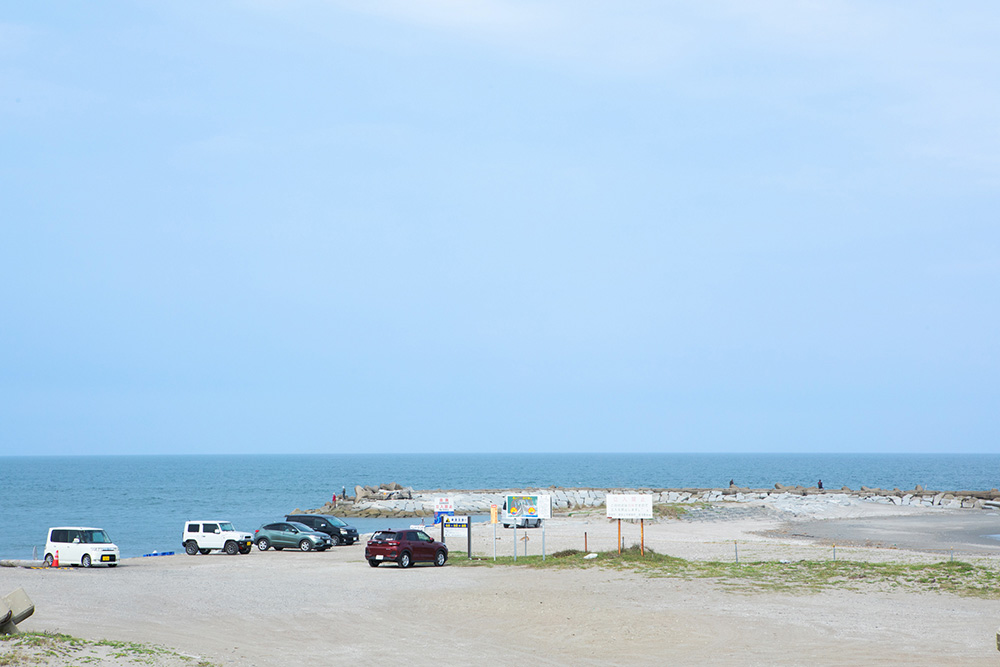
[{"x1": 0, "y1": 503, "x2": 1000, "y2": 666}]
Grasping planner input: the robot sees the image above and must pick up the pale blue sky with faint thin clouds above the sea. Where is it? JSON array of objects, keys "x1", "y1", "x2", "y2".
[{"x1": 0, "y1": 0, "x2": 1000, "y2": 455}]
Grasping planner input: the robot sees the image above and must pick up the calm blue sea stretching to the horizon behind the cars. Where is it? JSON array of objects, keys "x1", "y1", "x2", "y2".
[{"x1": 0, "y1": 454, "x2": 1000, "y2": 558}]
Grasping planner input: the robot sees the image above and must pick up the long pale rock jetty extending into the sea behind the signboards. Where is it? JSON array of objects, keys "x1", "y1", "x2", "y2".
[{"x1": 294, "y1": 482, "x2": 1000, "y2": 518}]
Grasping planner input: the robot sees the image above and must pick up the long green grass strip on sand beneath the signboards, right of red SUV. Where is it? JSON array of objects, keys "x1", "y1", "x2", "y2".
[{"x1": 449, "y1": 545, "x2": 1000, "y2": 600}]
